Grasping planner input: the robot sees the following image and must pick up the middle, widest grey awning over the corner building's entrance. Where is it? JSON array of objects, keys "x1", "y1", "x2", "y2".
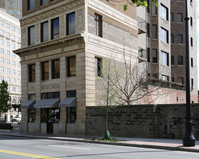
[{"x1": 34, "y1": 98, "x2": 60, "y2": 108}]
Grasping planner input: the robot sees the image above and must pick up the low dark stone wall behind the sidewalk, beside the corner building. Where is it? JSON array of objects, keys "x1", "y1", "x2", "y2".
[{"x1": 86, "y1": 104, "x2": 199, "y2": 138}]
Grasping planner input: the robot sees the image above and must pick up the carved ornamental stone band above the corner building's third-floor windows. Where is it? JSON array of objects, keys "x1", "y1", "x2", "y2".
[{"x1": 20, "y1": 0, "x2": 85, "y2": 26}]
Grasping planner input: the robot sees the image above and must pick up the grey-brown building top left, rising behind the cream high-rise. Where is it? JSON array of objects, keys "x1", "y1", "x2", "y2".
[{"x1": 0, "y1": 0, "x2": 22, "y2": 19}]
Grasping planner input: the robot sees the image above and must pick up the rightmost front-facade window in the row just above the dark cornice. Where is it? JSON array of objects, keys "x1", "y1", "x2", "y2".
[{"x1": 66, "y1": 12, "x2": 75, "y2": 35}]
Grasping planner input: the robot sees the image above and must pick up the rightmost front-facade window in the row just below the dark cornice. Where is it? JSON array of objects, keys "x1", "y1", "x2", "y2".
[{"x1": 67, "y1": 56, "x2": 76, "y2": 77}]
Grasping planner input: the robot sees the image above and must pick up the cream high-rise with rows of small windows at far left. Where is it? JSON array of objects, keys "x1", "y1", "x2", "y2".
[{"x1": 0, "y1": 8, "x2": 21, "y2": 121}]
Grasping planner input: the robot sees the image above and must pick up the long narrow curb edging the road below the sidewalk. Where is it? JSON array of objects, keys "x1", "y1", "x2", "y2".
[{"x1": 0, "y1": 132, "x2": 199, "y2": 153}]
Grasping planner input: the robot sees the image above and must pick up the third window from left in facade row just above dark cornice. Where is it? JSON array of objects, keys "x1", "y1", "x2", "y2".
[{"x1": 51, "y1": 18, "x2": 59, "y2": 39}]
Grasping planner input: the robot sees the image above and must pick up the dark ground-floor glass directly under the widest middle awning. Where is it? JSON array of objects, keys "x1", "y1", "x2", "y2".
[{"x1": 41, "y1": 108, "x2": 60, "y2": 123}]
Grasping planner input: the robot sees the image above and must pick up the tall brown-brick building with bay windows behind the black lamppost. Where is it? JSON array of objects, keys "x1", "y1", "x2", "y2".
[{"x1": 137, "y1": 0, "x2": 198, "y2": 104}]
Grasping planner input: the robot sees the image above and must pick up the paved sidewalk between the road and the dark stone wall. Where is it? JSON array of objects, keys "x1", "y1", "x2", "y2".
[{"x1": 0, "y1": 130, "x2": 199, "y2": 153}]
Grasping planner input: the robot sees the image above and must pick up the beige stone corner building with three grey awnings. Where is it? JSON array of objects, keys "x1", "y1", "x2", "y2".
[{"x1": 15, "y1": 0, "x2": 138, "y2": 135}]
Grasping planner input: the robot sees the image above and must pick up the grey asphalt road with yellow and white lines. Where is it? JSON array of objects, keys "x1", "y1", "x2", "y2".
[{"x1": 0, "y1": 136, "x2": 199, "y2": 159}]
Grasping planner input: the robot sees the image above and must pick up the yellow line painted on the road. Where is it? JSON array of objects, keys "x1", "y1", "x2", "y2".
[{"x1": 0, "y1": 150, "x2": 59, "y2": 159}]
